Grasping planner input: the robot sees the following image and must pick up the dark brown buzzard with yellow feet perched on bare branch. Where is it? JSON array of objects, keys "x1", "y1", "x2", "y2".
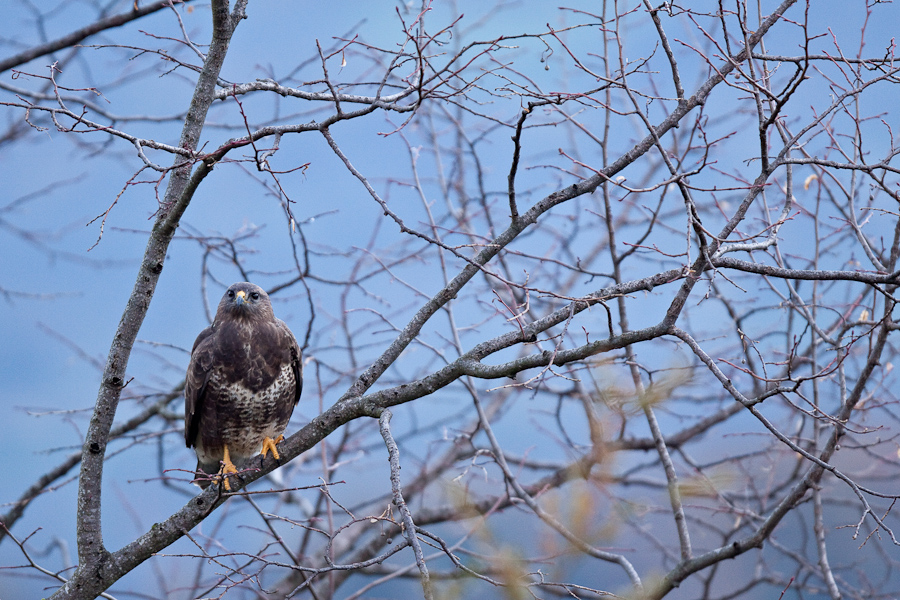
[{"x1": 184, "y1": 282, "x2": 303, "y2": 490}]
